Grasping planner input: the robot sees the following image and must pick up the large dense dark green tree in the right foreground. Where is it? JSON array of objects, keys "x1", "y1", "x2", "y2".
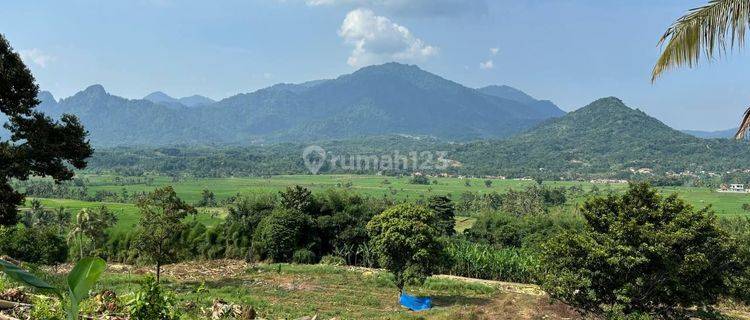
[{"x1": 542, "y1": 184, "x2": 744, "y2": 318}]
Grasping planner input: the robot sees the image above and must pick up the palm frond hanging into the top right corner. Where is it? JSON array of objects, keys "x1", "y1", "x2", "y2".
[{"x1": 651, "y1": 0, "x2": 750, "y2": 82}]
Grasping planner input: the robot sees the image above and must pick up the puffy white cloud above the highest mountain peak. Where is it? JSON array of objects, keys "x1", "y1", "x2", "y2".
[{"x1": 342, "y1": 8, "x2": 438, "y2": 67}]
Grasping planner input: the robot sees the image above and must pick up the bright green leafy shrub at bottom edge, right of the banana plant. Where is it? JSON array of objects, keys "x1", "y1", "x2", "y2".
[{"x1": 128, "y1": 276, "x2": 180, "y2": 320}]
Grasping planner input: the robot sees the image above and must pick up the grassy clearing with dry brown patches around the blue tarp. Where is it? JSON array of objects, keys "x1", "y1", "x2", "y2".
[{"x1": 82, "y1": 261, "x2": 571, "y2": 319}]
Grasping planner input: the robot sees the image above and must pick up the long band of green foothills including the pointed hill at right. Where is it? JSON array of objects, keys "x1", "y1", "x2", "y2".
[{"x1": 90, "y1": 97, "x2": 750, "y2": 180}]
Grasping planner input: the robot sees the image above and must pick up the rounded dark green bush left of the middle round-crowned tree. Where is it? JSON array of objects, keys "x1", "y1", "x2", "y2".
[{"x1": 253, "y1": 209, "x2": 311, "y2": 262}]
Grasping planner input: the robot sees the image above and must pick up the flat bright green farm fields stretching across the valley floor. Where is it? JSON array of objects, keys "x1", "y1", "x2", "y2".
[{"x1": 42, "y1": 174, "x2": 750, "y2": 216}]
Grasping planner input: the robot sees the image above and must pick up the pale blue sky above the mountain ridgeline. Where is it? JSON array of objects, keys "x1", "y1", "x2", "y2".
[{"x1": 0, "y1": 0, "x2": 750, "y2": 130}]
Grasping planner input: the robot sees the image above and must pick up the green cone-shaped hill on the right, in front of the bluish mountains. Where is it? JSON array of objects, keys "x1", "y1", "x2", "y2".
[{"x1": 456, "y1": 98, "x2": 750, "y2": 178}]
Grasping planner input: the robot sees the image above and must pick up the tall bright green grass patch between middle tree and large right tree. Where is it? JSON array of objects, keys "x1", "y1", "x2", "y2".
[{"x1": 443, "y1": 240, "x2": 539, "y2": 283}]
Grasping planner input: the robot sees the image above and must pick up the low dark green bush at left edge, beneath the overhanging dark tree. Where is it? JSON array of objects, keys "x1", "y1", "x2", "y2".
[{"x1": 0, "y1": 225, "x2": 68, "y2": 265}]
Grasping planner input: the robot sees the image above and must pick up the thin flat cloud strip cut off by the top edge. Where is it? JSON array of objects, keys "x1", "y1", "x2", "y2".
[{"x1": 305, "y1": 0, "x2": 488, "y2": 16}]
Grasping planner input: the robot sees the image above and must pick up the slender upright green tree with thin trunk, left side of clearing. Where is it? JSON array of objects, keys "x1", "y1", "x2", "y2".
[{"x1": 136, "y1": 186, "x2": 197, "y2": 282}]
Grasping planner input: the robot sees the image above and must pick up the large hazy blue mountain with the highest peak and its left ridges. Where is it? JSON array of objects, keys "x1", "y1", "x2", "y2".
[{"x1": 33, "y1": 63, "x2": 564, "y2": 146}]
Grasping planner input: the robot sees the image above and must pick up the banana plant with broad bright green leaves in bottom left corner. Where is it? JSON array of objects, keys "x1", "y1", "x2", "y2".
[{"x1": 0, "y1": 258, "x2": 107, "y2": 320}]
